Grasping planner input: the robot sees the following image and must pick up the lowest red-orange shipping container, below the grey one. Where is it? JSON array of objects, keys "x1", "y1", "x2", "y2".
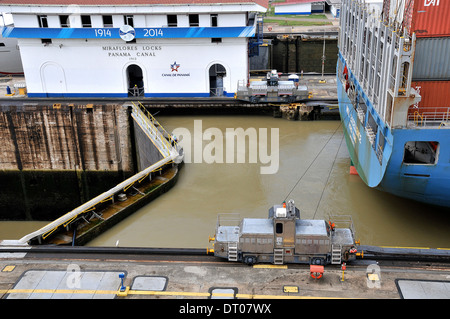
[{"x1": 409, "y1": 81, "x2": 450, "y2": 119}]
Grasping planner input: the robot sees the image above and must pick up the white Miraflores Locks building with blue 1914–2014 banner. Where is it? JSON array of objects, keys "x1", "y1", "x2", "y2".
[{"x1": 0, "y1": 0, "x2": 268, "y2": 97}]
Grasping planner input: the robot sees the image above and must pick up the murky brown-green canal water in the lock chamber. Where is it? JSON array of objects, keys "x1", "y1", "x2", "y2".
[{"x1": 0, "y1": 115, "x2": 450, "y2": 248}]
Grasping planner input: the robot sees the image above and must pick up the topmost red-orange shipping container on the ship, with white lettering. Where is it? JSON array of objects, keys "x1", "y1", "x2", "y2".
[{"x1": 383, "y1": 0, "x2": 450, "y2": 37}]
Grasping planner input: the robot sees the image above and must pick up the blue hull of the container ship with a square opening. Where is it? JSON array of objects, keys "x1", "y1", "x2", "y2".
[{"x1": 337, "y1": 55, "x2": 450, "y2": 207}]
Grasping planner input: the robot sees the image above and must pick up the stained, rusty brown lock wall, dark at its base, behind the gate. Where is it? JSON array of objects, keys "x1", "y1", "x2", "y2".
[{"x1": 0, "y1": 104, "x2": 163, "y2": 220}]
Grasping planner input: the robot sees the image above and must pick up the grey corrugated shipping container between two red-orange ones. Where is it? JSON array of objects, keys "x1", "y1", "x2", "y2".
[{"x1": 412, "y1": 37, "x2": 450, "y2": 81}]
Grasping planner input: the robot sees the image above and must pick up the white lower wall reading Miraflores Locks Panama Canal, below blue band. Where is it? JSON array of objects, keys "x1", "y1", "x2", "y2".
[{"x1": 19, "y1": 38, "x2": 248, "y2": 94}]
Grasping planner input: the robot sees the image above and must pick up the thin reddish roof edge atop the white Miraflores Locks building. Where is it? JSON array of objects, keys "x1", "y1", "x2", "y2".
[{"x1": 0, "y1": 0, "x2": 269, "y2": 8}]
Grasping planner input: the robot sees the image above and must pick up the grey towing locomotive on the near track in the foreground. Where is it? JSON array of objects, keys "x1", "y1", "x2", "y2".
[{"x1": 210, "y1": 200, "x2": 357, "y2": 266}]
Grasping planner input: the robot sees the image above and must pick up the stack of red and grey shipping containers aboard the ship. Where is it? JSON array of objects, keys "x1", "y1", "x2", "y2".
[{"x1": 383, "y1": 0, "x2": 450, "y2": 120}]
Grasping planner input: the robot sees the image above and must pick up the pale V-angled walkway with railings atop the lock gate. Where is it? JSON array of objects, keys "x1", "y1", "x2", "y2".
[{"x1": 0, "y1": 102, "x2": 183, "y2": 246}]
